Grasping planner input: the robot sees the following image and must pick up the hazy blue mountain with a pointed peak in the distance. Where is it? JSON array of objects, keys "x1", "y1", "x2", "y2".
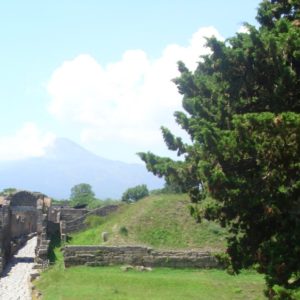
[{"x1": 0, "y1": 138, "x2": 163, "y2": 199}]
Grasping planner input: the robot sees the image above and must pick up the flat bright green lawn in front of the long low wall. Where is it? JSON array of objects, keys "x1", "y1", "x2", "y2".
[{"x1": 36, "y1": 265, "x2": 264, "y2": 300}]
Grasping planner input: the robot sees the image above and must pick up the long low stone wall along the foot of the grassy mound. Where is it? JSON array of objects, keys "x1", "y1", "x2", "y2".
[{"x1": 64, "y1": 246, "x2": 220, "y2": 268}]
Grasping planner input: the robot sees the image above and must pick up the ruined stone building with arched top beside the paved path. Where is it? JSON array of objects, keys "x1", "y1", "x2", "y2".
[{"x1": 0, "y1": 191, "x2": 51, "y2": 273}]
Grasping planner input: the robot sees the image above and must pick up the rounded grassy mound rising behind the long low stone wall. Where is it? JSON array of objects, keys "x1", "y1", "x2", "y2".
[{"x1": 70, "y1": 195, "x2": 225, "y2": 250}]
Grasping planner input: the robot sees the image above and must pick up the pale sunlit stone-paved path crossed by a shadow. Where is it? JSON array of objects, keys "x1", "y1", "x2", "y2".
[{"x1": 0, "y1": 237, "x2": 37, "y2": 300}]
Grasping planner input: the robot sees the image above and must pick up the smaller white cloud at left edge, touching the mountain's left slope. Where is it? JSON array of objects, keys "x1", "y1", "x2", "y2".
[{"x1": 0, "y1": 123, "x2": 55, "y2": 161}]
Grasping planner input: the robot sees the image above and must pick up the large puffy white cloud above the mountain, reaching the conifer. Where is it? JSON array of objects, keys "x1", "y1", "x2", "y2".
[{"x1": 47, "y1": 27, "x2": 222, "y2": 156}]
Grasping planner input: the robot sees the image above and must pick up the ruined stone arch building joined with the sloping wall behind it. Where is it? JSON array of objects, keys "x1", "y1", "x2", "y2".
[{"x1": 0, "y1": 191, "x2": 118, "y2": 275}]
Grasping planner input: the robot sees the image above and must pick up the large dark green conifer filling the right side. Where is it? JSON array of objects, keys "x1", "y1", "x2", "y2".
[{"x1": 139, "y1": 0, "x2": 300, "y2": 299}]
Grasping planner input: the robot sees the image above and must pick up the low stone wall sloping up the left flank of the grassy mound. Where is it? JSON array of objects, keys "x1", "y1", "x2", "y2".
[{"x1": 63, "y1": 205, "x2": 118, "y2": 234}]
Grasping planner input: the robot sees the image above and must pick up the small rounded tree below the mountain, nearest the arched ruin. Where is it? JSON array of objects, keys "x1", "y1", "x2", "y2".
[{"x1": 70, "y1": 183, "x2": 96, "y2": 206}]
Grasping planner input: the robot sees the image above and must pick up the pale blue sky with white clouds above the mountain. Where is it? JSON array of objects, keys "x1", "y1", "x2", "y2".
[{"x1": 0, "y1": 0, "x2": 260, "y2": 162}]
